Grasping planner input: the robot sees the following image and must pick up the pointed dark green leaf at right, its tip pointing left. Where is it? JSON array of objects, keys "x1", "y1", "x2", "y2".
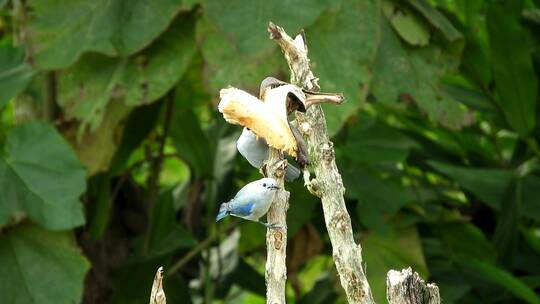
[{"x1": 428, "y1": 161, "x2": 514, "y2": 209}]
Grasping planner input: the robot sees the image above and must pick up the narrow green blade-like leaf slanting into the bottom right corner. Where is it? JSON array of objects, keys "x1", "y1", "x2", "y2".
[{"x1": 461, "y1": 258, "x2": 540, "y2": 304}]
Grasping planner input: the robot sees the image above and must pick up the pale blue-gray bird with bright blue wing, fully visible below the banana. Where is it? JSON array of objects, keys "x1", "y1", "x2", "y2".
[{"x1": 216, "y1": 177, "x2": 279, "y2": 228}]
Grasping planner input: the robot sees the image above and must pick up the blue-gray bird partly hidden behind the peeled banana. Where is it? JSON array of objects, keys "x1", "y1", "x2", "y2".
[{"x1": 236, "y1": 128, "x2": 300, "y2": 182}]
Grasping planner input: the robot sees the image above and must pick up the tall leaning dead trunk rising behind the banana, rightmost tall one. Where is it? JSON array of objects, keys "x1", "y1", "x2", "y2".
[{"x1": 268, "y1": 23, "x2": 374, "y2": 303}]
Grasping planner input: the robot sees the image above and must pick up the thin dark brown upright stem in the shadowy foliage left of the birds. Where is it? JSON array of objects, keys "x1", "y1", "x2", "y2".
[{"x1": 143, "y1": 89, "x2": 174, "y2": 254}]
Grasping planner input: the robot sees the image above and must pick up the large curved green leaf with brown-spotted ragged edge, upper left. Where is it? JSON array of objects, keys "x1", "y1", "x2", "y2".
[{"x1": 59, "y1": 15, "x2": 195, "y2": 130}]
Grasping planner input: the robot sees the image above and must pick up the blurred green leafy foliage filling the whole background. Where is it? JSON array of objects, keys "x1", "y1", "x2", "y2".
[{"x1": 0, "y1": 0, "x2": 540, "y2": 304}]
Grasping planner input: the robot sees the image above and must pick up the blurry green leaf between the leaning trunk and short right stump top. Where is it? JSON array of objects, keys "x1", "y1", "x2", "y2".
[{"x1": 362, "y1": 226, "x2": 428, "y2": 303}]
